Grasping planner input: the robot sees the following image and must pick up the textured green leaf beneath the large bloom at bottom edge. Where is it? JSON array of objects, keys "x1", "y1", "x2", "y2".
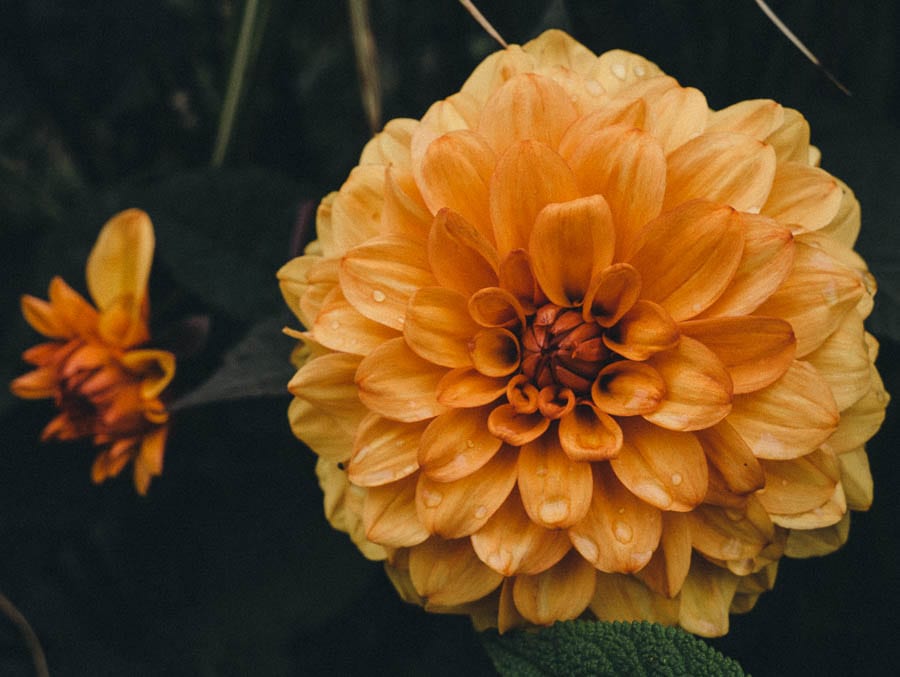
[{"x1": 481, "y1": 621, "x2": 745, "y2": 677}]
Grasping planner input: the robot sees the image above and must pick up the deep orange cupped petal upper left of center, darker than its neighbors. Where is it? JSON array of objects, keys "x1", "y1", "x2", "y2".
[{"x1": 428, "y1": 209, "x2": 500, "y2": 296}]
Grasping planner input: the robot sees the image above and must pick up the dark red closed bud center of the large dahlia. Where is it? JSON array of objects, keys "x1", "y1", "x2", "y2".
[{"x1": 522, "y1": 303, "x2": 610, "y2": 395}]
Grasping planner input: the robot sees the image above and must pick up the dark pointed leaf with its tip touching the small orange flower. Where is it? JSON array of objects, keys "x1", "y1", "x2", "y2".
[{"x1": 171, "y1": 318, "x2": 293, "y2": 411}]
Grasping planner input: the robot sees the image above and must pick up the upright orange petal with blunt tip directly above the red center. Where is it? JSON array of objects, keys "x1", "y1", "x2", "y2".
[{"x1": 528, "y1": 195, "x2": 615, "y2": 307}]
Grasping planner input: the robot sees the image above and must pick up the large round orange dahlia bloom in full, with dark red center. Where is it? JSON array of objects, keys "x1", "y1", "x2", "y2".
[{"x1": 279, "y1": 31, "x2": 887, "y2": 636}]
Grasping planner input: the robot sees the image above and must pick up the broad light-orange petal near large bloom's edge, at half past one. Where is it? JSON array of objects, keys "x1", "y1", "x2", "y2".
[{"x1": 663, "y1": 132, "x2": 775, "y2": 213}]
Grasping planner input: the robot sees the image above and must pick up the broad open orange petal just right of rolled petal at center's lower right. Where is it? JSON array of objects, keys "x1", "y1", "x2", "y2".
[{"x1": 644, "y1": 336, "x2": 733, "y2": 430}]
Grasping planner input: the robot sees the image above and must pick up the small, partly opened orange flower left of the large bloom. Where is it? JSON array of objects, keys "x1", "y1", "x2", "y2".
[{"x1": 11, "y1": 209, "x2": 175, "y2": 494}]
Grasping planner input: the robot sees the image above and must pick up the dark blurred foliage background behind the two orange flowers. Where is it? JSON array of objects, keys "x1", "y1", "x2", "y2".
[{"x1": 0, "y1": 0, "x2": 900, "y2": 677}]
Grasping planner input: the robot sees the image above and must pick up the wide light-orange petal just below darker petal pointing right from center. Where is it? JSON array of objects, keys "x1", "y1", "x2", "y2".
[{"x1": 728, "y1": 362, "x2": 840, "y2": 460}]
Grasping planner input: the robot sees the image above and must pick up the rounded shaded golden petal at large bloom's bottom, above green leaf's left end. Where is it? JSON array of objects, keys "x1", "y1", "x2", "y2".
[{"x1": 513, "y1": 551, "x2": 597, "y2": 625}]
